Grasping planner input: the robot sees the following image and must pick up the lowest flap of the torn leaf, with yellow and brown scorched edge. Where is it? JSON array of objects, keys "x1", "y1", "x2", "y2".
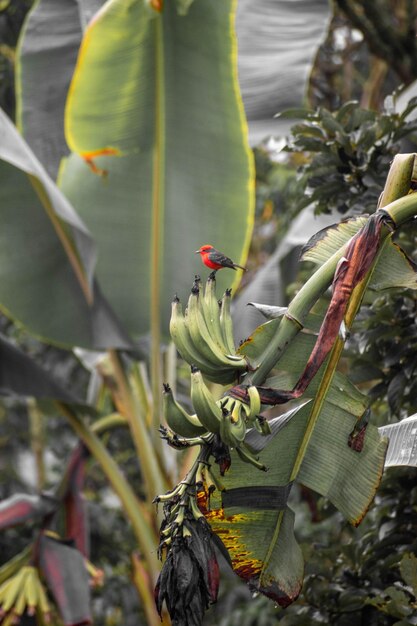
[{"x1": 206, "y1": 464, "x2": 304, "y2": 606}]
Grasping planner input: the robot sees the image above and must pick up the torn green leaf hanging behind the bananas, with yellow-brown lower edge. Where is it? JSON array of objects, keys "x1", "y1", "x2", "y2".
[{"x1": 208, "y1": 320, "x2": 387, "y2": 606}]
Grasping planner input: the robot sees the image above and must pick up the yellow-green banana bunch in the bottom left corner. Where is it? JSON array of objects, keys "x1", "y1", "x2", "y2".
[{"x1": 0, "y1": 565, "x2": 51, "y2": 623}]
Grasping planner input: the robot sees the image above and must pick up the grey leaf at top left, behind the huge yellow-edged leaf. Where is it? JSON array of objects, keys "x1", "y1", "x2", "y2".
[{"x1": 16, "y1": 0, "x2": 103, "y2": 178}]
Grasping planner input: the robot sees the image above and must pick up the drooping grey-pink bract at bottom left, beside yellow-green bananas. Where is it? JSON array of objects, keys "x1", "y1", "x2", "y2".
[{"x1": 39, "y1": 534, "x2": 92, "y2": 626}]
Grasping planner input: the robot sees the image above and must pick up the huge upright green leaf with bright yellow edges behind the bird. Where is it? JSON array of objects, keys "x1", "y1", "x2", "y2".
[{"x1": 60, "y1": 0, "x2": 253, "y2": 334}]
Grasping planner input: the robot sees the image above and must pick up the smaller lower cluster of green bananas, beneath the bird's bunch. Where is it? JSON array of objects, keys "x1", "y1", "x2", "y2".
[{"x1": 191, "y1": 368, "x2": 267, "y2": 470}]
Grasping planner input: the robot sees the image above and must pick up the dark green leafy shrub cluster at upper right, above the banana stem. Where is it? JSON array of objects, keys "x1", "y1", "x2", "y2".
[{"x1": 286, "y1": 99, "x2": 417, "y2": 215}]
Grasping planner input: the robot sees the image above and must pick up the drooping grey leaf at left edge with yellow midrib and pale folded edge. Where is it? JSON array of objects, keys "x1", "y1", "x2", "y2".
[{"x1": 0, "y1": 111, "x2": 129, "y2": 347}]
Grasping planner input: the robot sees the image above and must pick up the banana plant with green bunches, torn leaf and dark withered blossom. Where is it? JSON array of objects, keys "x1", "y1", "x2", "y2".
[{"x1": 156, "y1": 154, "x2": 417, "y2": 624}]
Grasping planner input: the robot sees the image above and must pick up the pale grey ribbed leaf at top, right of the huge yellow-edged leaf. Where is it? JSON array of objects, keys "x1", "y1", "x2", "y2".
[{"x1": 236, "y1": 0, "x2": 331, "y2": 145}]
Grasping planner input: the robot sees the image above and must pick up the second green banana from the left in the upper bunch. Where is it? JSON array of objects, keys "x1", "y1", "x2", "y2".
[{"x1": 185, "y1": 286, "x2": 247, "y2": 371}]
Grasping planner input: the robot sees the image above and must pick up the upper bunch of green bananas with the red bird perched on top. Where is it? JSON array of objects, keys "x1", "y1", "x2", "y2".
[{"x1": 169, "y1": 276, "x2": 248, "y2": 385}]
